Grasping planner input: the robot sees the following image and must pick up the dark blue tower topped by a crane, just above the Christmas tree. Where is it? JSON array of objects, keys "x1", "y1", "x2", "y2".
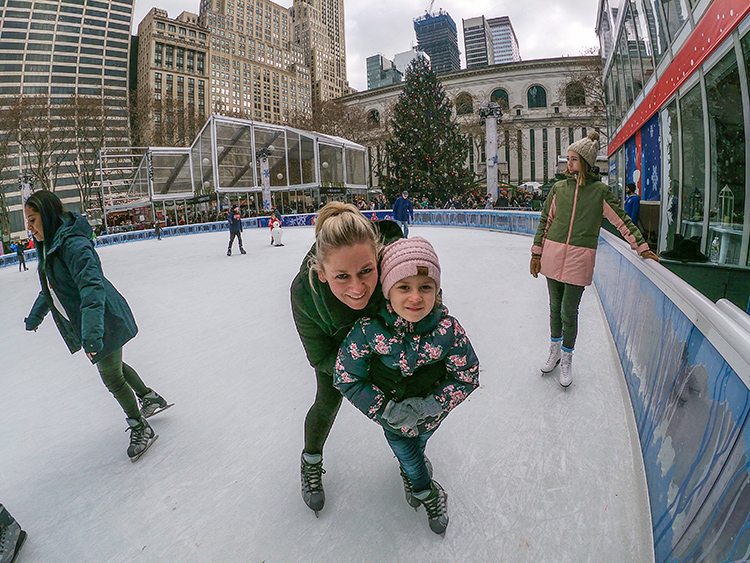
[{"x1": 414, "y1": 10, "x2": 461, "y2": 74}]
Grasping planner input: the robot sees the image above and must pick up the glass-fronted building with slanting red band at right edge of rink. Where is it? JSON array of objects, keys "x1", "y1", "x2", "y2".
[{"x1": 597, "y1": 0, "x2": 750, "y2": 274}]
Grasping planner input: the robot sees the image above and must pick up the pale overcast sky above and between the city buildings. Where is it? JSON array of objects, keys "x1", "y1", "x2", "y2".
[{"x1": 133, "y1": 0, "x2": 599, "y2": 90}]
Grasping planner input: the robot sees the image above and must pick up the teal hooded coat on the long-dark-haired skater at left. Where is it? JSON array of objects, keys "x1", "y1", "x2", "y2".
[{"x1": 26, "y1": 213, "x2": 138, "y2": 363}]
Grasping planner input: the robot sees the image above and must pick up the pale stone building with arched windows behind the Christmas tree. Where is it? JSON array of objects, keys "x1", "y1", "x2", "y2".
[{"x1": 341, "y1": 57, "x2": 607, "y2": 187}]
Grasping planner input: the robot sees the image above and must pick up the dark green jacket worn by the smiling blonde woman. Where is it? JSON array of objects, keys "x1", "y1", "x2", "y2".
[{"x1": 290, "y1": 221, "x2": 403, "y2": 378}]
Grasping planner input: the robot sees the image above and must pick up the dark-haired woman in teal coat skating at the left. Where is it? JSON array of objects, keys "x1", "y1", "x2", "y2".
[{"x1": 24, "y1": 190, "x2": 171, "y2": 461}]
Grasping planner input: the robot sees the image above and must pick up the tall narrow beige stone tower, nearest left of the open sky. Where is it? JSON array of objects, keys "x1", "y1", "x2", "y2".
[{"x1": 291, "y1": 0, "x2": 349, "y2": 101}]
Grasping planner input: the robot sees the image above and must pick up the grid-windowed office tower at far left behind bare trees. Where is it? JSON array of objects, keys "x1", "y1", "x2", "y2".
[{"x1": 0, "y1": 0, "x2": 133, "y2": 238}]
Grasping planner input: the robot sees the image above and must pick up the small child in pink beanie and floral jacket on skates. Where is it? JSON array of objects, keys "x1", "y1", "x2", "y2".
[{"x1": 334, "y1": 237, "x2": 479, "y2": 536}]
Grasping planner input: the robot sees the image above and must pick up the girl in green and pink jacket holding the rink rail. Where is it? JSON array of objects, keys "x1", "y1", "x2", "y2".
[{"x1": 529, "y1": 131, "x2": 659, "y2": 387}]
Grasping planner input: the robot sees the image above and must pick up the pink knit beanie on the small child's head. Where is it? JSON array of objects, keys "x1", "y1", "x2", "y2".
[{"x1": 380, "y1": 237, "x2": 440, "y2": 299}]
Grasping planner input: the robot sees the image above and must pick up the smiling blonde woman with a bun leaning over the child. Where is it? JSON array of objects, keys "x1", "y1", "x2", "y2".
[{"x1": 291, "y1": 201, "x2": 403, "y2": 516}]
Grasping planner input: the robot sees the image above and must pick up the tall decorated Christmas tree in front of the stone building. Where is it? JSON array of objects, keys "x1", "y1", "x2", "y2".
[{"x1": 383, "y1": 57, "x2": 474, "y2": 205}]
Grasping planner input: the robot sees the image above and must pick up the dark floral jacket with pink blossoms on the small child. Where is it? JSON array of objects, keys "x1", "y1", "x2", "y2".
[{"x1": 333, "y1": 303, "x2": 479, "y2": 436}]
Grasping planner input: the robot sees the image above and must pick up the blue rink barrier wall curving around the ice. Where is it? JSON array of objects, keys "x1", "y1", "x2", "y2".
[{"x1": 0, "y1": 209, "x2": 750, "y2": 563}]
